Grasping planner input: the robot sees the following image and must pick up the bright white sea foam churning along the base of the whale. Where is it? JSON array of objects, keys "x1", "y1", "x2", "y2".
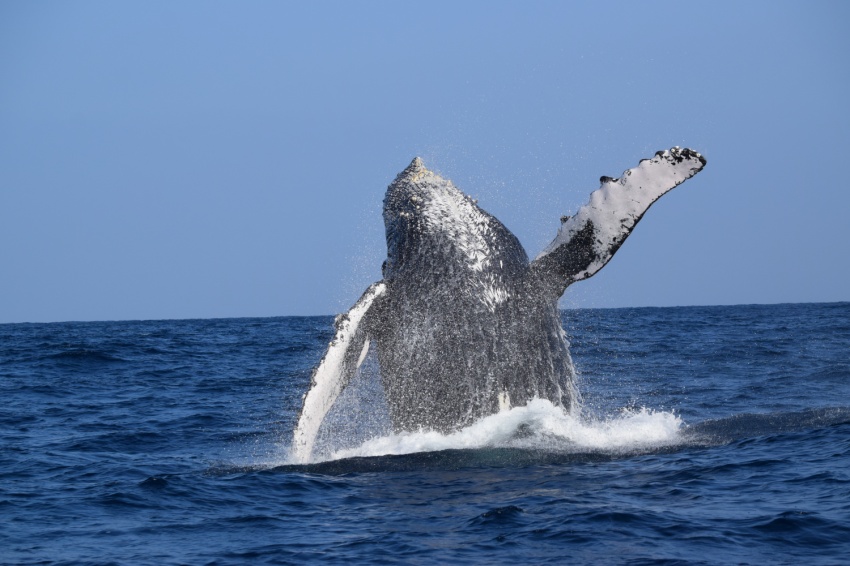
[{"x1": 298, "y1": 399, "x2": 683, "y2": 466}]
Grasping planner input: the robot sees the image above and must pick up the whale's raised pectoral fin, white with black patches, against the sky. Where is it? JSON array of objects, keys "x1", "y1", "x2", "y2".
[{"x1": 531, "y1": 147, "x2": 706, "y2": 297}]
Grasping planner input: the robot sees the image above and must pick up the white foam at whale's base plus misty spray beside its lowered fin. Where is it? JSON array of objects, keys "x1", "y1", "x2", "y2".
[{"x1": 284, "y1": 332, "x2": 688, "y2": 465}]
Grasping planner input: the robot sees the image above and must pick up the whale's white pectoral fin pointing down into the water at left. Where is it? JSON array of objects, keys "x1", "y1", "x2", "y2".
[{"x1": 291, "y1": 282, "x2": 386, "y2": 463}]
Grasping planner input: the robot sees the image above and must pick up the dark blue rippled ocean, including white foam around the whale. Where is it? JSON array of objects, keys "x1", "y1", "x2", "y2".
[{"x1": 0, "y1": 303, "x2": 850, "y2": 564}]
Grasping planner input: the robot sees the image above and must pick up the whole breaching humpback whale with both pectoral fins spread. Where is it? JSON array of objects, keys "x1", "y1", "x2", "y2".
[{"x1": 292, "y1": 147, "x2": 706, "y2": 462}]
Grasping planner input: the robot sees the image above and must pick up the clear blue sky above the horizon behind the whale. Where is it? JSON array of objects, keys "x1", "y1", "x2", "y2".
[{"x1": 0, "y1": 0, "x2": 850, "y2": 323}]
